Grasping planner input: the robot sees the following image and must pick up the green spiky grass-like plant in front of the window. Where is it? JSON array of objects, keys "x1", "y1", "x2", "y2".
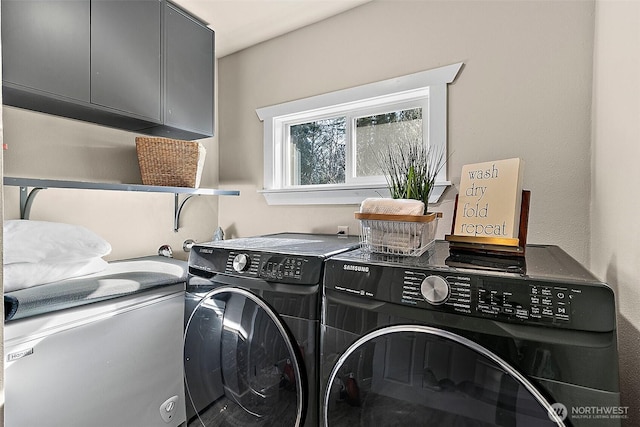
[{"x1": 379, "y1": 141, "x2": 444, "y2": 214}]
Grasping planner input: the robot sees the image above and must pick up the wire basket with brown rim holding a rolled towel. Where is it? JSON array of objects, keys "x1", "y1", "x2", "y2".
[{"x1": 355, "y1": 212, "x2": 442, "y2": 256}]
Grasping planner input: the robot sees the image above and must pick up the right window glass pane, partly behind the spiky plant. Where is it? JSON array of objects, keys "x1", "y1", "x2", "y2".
[{"x1": 354, "y1": 108, "x2": 422, "y2": 177}]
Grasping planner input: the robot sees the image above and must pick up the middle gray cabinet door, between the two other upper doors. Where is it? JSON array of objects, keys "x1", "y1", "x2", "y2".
[{"x1": 91, "y1": 0, "x2": 162, "y2": 122}]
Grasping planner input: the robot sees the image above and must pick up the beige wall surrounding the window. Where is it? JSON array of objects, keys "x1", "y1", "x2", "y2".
[{"x1": 219, "y1": 1, "x2": 594, "y2": 262}]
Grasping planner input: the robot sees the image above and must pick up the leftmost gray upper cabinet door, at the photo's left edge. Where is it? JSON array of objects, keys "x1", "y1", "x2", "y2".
[{"x1": 2, "y1": 0, "x2": 90, "y2": 102}]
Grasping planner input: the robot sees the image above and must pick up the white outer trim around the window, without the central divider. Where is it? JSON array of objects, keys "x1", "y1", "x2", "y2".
[{"x1": 256, "y1": 62, "x2": 463, "y2": 205}]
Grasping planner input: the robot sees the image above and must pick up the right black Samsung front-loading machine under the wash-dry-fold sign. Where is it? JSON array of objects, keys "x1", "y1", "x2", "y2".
[{"x1": 320, "y1": 241, "x2": 625, "y2": 427}]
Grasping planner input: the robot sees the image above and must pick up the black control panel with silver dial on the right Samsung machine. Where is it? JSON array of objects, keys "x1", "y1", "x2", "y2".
[{"x1": 324, "y1": 259, "x2": 615, "y2": 331}]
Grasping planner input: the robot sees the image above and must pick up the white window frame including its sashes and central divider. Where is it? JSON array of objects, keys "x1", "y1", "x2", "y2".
[{"x1": 256, "y1": 62, "x2": 463, "y2": 205}]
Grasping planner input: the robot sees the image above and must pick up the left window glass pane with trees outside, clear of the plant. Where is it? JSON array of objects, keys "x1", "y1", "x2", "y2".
[{"x1": 288, "y1": 117, "x2": 346, "y2": 185}]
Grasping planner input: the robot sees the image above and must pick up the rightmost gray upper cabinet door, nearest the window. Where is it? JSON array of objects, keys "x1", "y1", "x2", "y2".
[{"x1": 165, "y1": 3, "x2": 214, "y2": 135}]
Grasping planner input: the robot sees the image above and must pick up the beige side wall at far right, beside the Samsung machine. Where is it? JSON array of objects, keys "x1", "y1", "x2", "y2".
[{"x1": 591, "y1": 1, "x2": 640, "y2": 425}]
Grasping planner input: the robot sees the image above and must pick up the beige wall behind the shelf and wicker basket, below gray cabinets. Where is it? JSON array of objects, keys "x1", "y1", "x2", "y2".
[{"x1": 3, "y1": 107, "x2": 218, "y2": 260}]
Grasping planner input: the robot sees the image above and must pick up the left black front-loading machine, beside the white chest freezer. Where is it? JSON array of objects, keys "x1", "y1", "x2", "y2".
[{"x1": 184, "y1": 233, "x2": 359, "y2": 427}]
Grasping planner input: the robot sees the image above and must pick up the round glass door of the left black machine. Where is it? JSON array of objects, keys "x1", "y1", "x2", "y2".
[{"x1": 185, "y1": 287, "x2": 306, "y2": 427}]
